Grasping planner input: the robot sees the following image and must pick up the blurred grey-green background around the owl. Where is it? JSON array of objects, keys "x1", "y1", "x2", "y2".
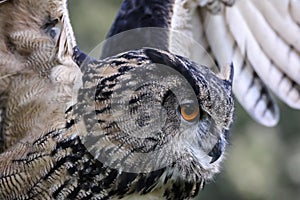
[{"x1": 69, "y1": 0, "x2": 300, "y2": 200}]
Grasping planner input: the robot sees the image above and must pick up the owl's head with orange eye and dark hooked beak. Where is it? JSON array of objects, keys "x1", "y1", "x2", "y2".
[{"x1": 76, "y1": 49, "x2": 234, "y2": 182}]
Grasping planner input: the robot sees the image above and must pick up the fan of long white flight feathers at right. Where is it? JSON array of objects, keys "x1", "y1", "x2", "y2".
[{"x1": 203, "y1": 0, "x2": 300, "y2": 126}]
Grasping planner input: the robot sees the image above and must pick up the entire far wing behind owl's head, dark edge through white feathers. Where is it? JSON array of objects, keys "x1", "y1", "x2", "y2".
[{"x1": 104, "y1": 0, "x2": 300, "y2": 126}]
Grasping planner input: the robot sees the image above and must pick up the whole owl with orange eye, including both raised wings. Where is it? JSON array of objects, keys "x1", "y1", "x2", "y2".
[{"x1": 0, "y1": 0, "x2": 298, "y2": 199}]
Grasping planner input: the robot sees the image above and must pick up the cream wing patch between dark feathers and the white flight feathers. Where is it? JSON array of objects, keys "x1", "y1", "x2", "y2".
[{"x1": 169, "y1": 0, "x2": 215, "y2": 68}]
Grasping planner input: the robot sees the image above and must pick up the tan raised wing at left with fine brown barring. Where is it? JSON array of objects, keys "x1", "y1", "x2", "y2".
[{"x1": 0, "y1": 0, "x2": 81, "y2": 149}]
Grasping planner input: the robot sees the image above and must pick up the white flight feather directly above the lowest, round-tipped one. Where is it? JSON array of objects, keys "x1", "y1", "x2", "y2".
[{"x1": 226, "y1": 1, "x2": 300, "y2": 108}]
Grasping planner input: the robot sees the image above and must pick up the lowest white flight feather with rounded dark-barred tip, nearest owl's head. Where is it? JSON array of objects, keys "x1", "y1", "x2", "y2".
[{"x1": 204, "y1": 10, "x2": 279, "y2": 126}]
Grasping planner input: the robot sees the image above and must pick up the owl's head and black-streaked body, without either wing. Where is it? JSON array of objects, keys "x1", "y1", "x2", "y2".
[{"x1": 0, "y1": 49, "x2": 234, "y2": 199}]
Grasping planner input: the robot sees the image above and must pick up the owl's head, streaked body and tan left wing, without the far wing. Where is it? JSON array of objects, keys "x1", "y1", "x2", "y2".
[{"x1": 0, "y1": 0, "x2": 234, "y2": 199}]
